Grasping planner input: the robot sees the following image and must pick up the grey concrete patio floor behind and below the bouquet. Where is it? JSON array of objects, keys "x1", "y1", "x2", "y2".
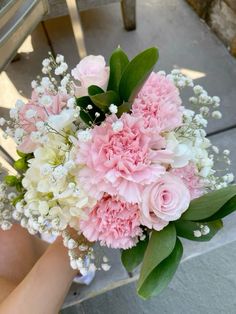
[{"x1": 0, "y1": 0, "x2": 236, "y2": 314}]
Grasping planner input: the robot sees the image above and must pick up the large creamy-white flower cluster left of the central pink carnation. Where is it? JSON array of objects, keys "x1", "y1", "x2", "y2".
[{"x1": 14, "y1": 133, "x2": 94, "y2": 235}]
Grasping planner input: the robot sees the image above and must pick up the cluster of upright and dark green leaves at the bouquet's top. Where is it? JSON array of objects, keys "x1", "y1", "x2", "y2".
[{"x1": 76, "y1": 47, "x2": 158, "y2": 126}]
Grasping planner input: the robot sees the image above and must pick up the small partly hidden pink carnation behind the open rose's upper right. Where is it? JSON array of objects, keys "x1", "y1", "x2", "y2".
[{"x1": 170, "y1": 163, "x2": 204, "y2": 200}]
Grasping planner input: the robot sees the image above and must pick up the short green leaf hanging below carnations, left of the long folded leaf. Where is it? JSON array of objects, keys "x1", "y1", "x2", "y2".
[{"x1": 121, "y1": 236, "x2": 148, "y2": 272}]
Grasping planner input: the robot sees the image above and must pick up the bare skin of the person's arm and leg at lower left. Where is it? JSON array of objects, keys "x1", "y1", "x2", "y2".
[{"x1": 0, "y1": 225, "x2": 76, "y2": 314}]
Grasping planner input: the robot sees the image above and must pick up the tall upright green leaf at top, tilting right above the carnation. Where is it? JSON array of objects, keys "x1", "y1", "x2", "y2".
[{"x1": 119, "y1": 47, "x2": 158, "y2": 101}]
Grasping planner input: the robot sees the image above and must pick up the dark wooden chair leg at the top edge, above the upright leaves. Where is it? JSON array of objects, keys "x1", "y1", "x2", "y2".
[{"x1": 121, "y1": 0, "x2": 136, "y2": 31}]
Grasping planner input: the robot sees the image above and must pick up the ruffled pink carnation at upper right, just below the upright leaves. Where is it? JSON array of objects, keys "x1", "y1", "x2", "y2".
[{"x1": 132, "y1": 72, "x2": 183, "y2": 132}]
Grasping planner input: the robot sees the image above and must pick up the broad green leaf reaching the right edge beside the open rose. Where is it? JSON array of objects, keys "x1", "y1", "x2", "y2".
[{"x1": 181, "y1": 185, "x2": 236, "y2": 221}]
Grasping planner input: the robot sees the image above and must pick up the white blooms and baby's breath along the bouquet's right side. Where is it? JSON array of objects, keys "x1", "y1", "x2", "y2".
[{"x1": 166, "y1": 74, "x2": 234, "y2": 190}]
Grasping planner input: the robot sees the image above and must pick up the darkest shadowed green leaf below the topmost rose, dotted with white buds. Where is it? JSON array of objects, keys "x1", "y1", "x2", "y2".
[{"x1": 76, "y1": 96, "x2": 105, "y2": 126}]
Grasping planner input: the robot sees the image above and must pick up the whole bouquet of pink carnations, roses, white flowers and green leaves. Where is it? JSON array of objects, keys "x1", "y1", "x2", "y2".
[{"x1": 0, "y1": 47, "x2": 236, "y2": 299}]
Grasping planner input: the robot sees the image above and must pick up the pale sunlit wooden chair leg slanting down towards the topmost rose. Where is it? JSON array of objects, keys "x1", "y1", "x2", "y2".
[{"x1": 66, "y1": 0, "x2": 87, "y2": 59}]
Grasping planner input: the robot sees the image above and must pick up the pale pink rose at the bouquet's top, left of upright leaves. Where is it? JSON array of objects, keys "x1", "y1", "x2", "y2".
[{"x1": 71, "y1": 55, "x2": 109, "y2": 97}]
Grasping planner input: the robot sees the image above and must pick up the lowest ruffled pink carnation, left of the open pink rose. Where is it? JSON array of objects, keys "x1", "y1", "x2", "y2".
[{"x1": 80, "y1": 195, "x2": 142, "y2": 249}]
